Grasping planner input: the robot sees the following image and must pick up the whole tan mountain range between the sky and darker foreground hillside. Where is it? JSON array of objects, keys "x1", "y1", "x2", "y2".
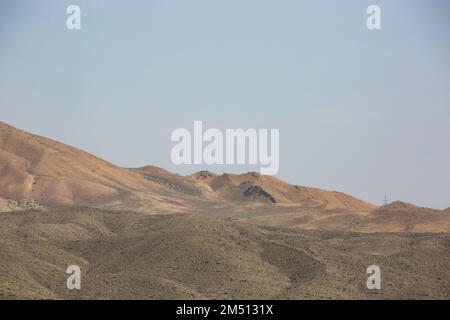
[{"x1": 0, "y1": 123, "x2": 450, "y2": 233}]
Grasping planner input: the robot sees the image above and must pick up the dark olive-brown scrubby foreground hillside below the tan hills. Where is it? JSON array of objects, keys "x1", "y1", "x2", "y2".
[{"x1": 0, "y1": 208, "x2": 450, "y2": 299}]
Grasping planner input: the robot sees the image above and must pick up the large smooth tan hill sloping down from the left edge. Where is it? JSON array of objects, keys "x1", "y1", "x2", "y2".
[{"x1": 0, "y1": 123, "x2": 188, "y2": 208}]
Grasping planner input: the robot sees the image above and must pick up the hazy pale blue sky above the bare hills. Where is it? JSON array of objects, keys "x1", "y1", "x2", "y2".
[{"x1": 0, "y1": 0, "x2": 450, "y2": 209}]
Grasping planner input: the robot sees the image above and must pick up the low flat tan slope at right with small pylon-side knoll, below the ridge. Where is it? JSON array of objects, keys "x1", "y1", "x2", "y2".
[{"x1": 225, "y1": 201, "x2": 450, "y2": 233}]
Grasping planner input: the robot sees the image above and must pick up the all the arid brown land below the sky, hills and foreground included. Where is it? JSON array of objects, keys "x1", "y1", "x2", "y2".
[{"x1": 0, "y1": 123, "x2": 450, "y2": 299}]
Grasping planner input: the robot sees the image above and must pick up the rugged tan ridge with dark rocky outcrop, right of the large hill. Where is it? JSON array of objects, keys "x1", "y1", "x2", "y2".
[{"x1": 134, "y1": 167, "x2": 376, "y2": 210}]
